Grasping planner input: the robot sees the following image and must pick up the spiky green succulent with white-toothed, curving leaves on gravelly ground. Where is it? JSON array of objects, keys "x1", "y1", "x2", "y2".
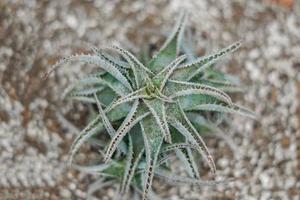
[{"x1": 46, "y1": 14, "x2": 255, "y2": 199}]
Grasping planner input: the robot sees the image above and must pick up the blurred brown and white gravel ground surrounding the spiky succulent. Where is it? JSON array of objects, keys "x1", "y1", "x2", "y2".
[{"x1": 0, "y1": 0, "x2": 300, "y2": 200}]
